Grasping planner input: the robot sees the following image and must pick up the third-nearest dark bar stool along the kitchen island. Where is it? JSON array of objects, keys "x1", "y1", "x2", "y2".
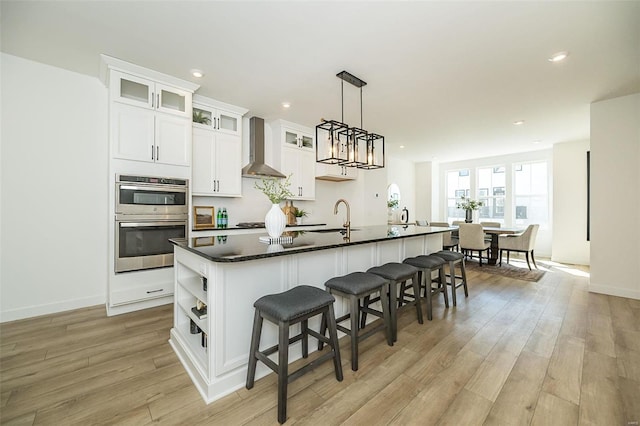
[{"x1": 361, "y1": 262, "x2": 424, "y2": 342}]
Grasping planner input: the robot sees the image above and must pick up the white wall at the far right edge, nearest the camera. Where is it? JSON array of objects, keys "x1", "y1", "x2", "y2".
[{"x1": 589, "y1": 94, "x2": 640, "y2": 299}]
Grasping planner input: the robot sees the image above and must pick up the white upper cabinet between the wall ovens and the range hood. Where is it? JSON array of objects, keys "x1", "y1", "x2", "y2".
[{"x1": 191, "y1": 95, "x2": 248, "y2": 197}]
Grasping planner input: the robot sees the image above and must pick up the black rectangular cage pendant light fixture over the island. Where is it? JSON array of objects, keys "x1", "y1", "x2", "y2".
[{"x1": 316, "y1": 71, "x2": 384, "y2": 170}]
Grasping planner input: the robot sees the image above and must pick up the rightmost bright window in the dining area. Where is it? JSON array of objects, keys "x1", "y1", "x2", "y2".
[{"x1": 513, "y1": 161, "x2": 549, "y2": 226}]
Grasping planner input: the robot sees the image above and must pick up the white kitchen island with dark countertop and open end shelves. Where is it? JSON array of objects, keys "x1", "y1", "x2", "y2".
[{"x1": 169, "y1": 225, "x2": 451, "y2": 403}]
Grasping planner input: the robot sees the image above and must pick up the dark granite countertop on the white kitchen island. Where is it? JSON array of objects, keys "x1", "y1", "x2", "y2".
[{"x1": 170, "y1": 225, "x2": 452, "y2": 262}]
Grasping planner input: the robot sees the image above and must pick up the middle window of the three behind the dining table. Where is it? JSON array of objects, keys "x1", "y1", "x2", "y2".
[{"x1": 477, "y1": 166, "x2": 506, "y2": 223}]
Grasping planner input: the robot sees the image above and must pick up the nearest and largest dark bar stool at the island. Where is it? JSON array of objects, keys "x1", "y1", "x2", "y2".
[{"x1": 247, "y1": 285, "x2": 342, "y2": 423}]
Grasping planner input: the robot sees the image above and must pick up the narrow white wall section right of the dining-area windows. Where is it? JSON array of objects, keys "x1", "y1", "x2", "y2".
[{"x1": 551, "y1": 141, "x2": 590, "y2": 265}]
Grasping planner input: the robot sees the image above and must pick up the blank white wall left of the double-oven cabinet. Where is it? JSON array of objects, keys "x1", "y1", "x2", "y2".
[{"x1": 0, "y1": 54, "x2": 108, "y2": 321}]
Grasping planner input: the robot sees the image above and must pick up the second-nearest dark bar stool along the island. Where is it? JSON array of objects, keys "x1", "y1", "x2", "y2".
[{"x1": 318, "y1": 272, "x2": 393, "y2": 371}]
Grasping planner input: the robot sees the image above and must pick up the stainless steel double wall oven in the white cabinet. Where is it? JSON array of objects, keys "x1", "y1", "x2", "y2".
[{"x1": 115, "y1": 174, "x2": 189, "y2": 273}]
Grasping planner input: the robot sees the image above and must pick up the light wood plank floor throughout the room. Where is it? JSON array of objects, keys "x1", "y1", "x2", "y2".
[{"x1": 0, "y1": 260, "x2": 640, "y2": 426}]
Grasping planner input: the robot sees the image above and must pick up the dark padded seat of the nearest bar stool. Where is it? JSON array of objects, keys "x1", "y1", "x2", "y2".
[{"x1": 253, "y1": 285, "x2": 336, "y2": 321}]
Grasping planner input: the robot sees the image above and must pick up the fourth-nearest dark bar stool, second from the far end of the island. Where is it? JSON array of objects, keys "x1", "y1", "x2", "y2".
[{"x1": 399, "y1": 255, "x2": 449, "y2": 321}]
